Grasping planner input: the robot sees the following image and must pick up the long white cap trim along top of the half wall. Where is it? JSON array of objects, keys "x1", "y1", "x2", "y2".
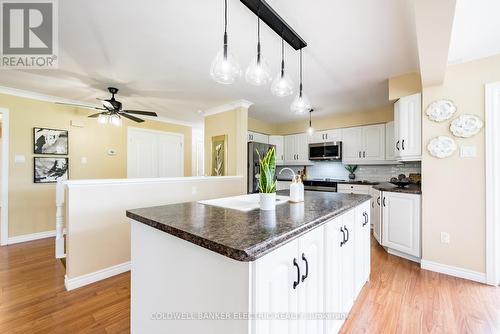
[{"x1": 65, "y1": 176, "x2": 243, "y2": 188}]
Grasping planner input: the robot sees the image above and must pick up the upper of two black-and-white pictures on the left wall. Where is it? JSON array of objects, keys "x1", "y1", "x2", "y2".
[{"x1": 33, "y1": 128, "x2": 68, "y2": 155}]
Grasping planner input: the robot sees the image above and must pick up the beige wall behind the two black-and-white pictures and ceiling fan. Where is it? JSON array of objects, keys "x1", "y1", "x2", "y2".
[{"x1": 0, "y1": 95, "x2": 191, "y2": 237}]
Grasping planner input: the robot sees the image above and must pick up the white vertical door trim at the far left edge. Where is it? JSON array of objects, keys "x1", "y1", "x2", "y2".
[{"x1": 0, "y1": 108, "x2": 10, "y2": 246}]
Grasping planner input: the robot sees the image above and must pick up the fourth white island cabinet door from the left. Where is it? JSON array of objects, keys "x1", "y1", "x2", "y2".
[{"x1": 340, "y1": 210, "x2": 355, "y2": 313}]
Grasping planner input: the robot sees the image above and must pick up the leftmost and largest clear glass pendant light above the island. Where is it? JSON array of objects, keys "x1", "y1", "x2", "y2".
[{"x1": 210, "y1": 0, "x2": 241, "y2": 85}]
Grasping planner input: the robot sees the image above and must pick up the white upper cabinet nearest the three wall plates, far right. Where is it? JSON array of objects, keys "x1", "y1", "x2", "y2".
[{"x1": 393, "y1": 93, "x2": 422, "y2": 161}]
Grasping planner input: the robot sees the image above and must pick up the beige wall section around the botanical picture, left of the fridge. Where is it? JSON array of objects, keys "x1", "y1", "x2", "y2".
[{"x1": 204, "y1": 107, "x2": 248, "y2": 185}]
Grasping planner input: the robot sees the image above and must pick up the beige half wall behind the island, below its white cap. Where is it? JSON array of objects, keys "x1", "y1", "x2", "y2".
[{"x1": 65, "y1": 177, "x2": 245, "y2": 280}]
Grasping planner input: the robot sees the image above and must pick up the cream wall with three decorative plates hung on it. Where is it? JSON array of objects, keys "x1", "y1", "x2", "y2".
[{"x1": 422, "y1": 55, "x2": 500, "y2": 272}]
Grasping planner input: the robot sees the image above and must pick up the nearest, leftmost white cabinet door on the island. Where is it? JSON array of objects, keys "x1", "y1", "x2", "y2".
[{"x1": 254, "y1": 240, "x2": 301, "y2": 334}]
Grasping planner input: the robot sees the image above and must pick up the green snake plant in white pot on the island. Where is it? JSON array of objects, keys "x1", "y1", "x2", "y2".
[{"x1": 257, "y1": 147, "x2": 276, "y2": 210}]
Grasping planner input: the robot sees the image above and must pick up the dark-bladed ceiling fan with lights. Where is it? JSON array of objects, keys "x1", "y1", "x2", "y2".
[{"x1": 57, "y1": 87, "x2": 158, "y2": 126}]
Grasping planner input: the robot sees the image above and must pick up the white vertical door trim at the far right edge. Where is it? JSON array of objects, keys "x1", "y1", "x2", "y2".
[{"x1": 485, "y1": 82, "x2": 500, "y2": 285}]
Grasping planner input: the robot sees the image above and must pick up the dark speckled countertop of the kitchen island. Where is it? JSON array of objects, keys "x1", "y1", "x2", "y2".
[{"x1": 127, "y1": 190, "x2": 370, "y2": 261}]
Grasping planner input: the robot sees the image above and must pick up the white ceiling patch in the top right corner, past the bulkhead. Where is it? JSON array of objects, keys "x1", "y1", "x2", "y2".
[{"x1": 448, "y1": 0, "x2": 500, "y2": 64}]
